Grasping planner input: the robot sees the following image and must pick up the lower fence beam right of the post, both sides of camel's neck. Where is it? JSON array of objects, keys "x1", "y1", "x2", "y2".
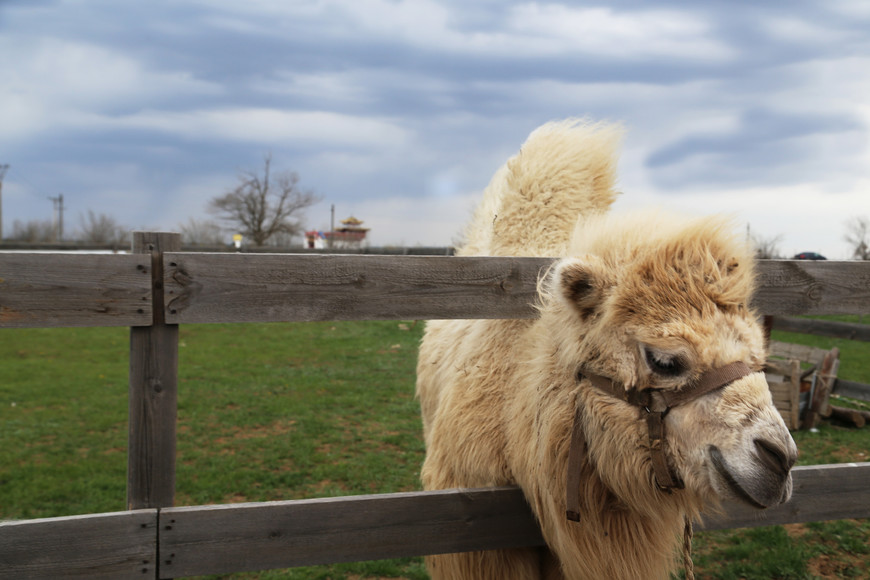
[{"x1": 160, "y1": 463, "x2": 870, "y2": 577}]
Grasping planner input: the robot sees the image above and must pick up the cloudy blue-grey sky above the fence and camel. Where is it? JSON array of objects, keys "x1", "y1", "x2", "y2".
[{"x1": 0, "y1": 0, "x2": 870, "y2": 258}]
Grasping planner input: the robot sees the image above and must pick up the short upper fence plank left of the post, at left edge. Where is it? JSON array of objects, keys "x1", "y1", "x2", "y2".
[{"x1": 0, "y1": 252, "x2": 151, "y2": 328}]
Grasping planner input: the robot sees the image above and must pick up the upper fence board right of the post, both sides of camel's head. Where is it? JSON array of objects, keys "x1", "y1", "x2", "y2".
[{"x1": 165, "y1": 252, "x2": 870, "y2": 323}]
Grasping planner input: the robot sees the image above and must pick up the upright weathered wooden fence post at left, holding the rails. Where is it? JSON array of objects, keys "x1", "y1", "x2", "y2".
[{"x1": 127, "y1": 232, "x2": 181, "y2": 510}]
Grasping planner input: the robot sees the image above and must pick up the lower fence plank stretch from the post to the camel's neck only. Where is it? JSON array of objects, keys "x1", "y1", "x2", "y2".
[{"x1": 160, "y1": 488, "x2": 543, "y2": 577}]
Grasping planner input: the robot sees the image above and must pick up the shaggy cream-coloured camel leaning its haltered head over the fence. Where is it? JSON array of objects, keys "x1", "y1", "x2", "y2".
[{"x1": 417, "y1": 120, "x2": 797, "y2": 580}]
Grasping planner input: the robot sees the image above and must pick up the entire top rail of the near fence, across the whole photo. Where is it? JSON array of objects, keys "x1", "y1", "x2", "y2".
[{"x1": 0, "y1": 252, "x2": 870, "y2": 328}]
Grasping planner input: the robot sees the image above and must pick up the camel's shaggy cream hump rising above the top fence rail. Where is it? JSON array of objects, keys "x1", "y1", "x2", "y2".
[{"x1": 457, "y1": 119, "x2": 622, "y2": 256}]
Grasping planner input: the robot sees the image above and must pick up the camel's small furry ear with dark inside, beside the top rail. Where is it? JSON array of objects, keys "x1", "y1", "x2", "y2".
[{"x1": 553, "y1": 255, "x2": 610, "y2": 319}]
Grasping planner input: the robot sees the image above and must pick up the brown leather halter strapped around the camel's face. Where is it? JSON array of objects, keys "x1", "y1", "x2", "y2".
[{"x1": 566, "y1": 361, "x2": 753, "y2": 522}]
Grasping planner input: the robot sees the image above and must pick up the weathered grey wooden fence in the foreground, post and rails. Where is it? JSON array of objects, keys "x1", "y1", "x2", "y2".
[{"x1": 0, "y1": 232, "x2": 870, "y2": 579}]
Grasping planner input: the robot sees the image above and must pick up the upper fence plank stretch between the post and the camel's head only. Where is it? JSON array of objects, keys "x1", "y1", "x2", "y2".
[{"x1": 166, "y1": 253, "x2": 552, "y2": 323}]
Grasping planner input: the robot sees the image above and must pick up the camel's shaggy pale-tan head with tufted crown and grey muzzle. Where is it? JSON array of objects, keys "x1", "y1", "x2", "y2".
[{"x1": 542, "y1": 214, "x2": 797, "y2": 509}]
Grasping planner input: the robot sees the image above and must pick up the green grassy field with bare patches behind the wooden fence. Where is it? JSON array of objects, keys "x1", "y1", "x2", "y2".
[{"x1": 0, "y1": 321, "x2": 870, "y2": 579}]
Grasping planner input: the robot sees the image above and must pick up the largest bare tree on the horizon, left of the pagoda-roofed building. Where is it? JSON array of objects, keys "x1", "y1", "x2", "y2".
[{"x1": 209, "y1": 155, "x2": 320, "y2": 246}]
